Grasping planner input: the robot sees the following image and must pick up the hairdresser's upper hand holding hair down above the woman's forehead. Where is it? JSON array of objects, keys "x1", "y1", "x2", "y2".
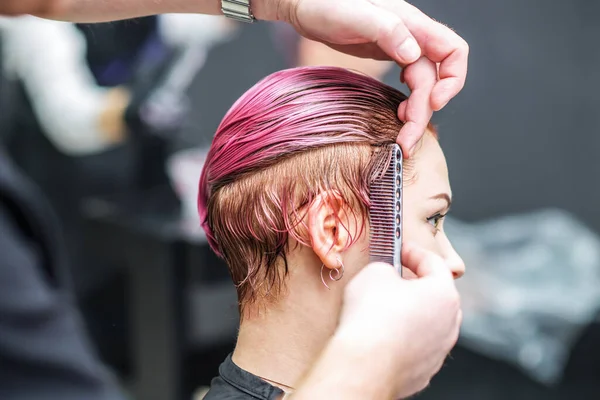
[{"x1": 272, "y1": 0, "x2": 469, "y2": 155}]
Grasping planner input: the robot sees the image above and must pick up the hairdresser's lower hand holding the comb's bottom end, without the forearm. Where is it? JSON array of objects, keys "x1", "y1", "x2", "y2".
[{"x1": 336, "y1": 243, "x2": 462, "y2": 397}]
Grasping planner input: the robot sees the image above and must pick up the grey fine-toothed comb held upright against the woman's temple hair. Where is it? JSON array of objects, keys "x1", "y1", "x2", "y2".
[{"x1": 369, "y1": 144, "x2": 402, "y2": 273}]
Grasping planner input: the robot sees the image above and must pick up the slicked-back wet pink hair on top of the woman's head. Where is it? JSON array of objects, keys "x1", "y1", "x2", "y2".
[{"x1": 198, "y1": 67, "x2": 406, "y2": 254}]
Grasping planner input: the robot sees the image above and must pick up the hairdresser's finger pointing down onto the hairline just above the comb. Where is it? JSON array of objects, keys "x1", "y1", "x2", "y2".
[{"x1": 398, "y1": 57, "x2": 437, "y2": 157}]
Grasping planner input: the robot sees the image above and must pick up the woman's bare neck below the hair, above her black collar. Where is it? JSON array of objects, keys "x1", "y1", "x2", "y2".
[{"x1": 233, "y1": 272, "x2": 341, "y2": 391}]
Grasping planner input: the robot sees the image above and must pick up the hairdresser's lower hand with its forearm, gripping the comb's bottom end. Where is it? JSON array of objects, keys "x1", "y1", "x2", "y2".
[{"x1": 292, "y1": 244, "x2": 462, "y2": 400}]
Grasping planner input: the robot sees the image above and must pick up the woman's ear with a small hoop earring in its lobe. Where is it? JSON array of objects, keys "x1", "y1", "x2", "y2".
[{"x1": 307, "y1": 190, "x2": 350, "y2": 269}]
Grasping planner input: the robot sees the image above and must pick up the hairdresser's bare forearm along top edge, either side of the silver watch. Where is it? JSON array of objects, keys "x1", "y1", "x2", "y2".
[{"x1": 44, "y1": 0, "x2": 286, "y2": 22}]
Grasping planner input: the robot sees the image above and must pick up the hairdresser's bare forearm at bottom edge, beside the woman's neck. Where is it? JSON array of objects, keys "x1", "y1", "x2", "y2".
[{"x1": 291, "y1": 336, "x2": 397, "y2": 400}]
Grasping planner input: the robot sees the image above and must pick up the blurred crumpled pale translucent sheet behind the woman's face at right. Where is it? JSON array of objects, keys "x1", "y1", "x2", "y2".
[{"x1": 446, "y1": 209, "x2": 600, "y2": 386}]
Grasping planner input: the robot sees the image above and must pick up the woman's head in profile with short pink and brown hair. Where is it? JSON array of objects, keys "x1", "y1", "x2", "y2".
[{"x1": 199, "y1": 67, "x2": 462, "y2": 307}]
